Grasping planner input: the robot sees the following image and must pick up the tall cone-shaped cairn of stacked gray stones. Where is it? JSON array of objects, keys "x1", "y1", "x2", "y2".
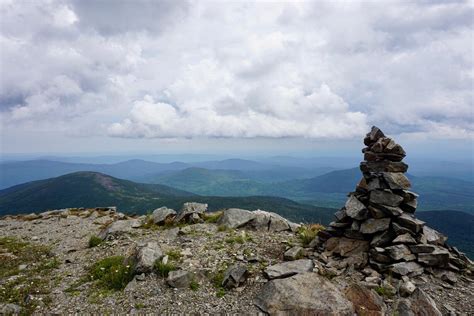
[{"x1": 318, "y1": 126, "x2": 471, "y2": 277}]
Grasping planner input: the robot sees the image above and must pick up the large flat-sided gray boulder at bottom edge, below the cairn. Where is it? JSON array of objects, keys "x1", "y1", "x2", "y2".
[{"x1": 255, "y1": 273, "x2": 354, "y2": 316}]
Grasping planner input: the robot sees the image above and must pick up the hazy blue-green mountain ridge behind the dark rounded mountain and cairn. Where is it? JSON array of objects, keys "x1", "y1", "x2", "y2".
[{"x1": 148, "y1": 168, "x2": 474, "y2": 214}]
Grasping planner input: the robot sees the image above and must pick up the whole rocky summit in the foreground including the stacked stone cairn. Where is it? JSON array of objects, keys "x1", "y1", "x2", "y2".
[{"x1": 0, "y1": 127, "x2": 474, "y2": 316}]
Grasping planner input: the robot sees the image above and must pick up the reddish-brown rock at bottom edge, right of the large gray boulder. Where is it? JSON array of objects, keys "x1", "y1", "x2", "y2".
[{"x1": 344, "y1": 284, "x2": 387, "y2": 316}]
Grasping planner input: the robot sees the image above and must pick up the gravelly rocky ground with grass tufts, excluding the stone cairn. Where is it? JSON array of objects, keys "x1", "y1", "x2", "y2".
[{"x1": 0, "y1": 204, "x2": 474, "y2": 315}]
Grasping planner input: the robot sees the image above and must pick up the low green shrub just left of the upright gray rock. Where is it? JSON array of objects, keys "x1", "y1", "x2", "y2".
[{"x1": 89, "y1": 256, "x2": 134, "y2": 290}]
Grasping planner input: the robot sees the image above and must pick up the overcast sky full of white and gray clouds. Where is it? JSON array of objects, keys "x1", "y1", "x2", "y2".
[{"x1": 0, "y1": 0, "x2": 474, "y2": 155}]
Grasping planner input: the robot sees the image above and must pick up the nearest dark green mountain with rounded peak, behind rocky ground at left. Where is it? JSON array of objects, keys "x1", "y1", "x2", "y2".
[{"x1": 0, "y1": 172, "x2": 335, "y2": 223}]
